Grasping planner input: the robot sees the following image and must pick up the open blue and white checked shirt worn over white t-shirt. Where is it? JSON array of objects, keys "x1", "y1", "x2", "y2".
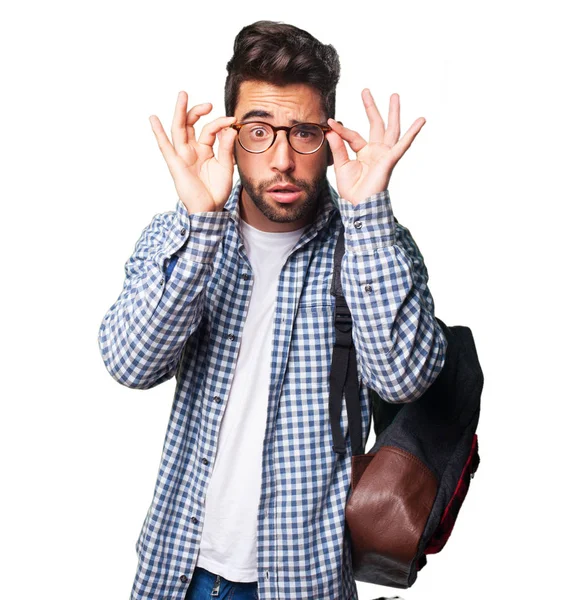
[{"x1": 99, "y1": 182, "x2": 446, "y2": 600}]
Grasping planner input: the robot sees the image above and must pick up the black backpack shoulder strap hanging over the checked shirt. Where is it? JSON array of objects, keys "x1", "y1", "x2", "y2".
[{"x1": 329, "y1": 229, "x2": 364, "y2": 455}]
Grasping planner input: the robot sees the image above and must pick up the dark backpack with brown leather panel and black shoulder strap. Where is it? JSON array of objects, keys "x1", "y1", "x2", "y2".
[{"x1": 329, "y1": 231, "x2": 483, "y2": 588}]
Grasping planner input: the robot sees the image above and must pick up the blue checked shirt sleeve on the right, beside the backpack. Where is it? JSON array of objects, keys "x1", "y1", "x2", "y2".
[{"x1": 338, "y1": 190, "x2": 447, "y2": 402}]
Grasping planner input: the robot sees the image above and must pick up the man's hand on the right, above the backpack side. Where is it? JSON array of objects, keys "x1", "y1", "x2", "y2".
[{"x1": 326, "y1": 88, "x2": 426, "y2": 206}]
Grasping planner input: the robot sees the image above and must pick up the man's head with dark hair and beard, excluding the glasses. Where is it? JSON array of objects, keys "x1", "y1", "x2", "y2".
[{"x1": 225, "y1": 21, "x2": 340, "y2": 231}]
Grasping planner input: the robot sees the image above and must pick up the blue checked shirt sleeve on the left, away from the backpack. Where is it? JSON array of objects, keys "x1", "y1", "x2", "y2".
[{"x1": 98, "y1": 200, "x2": 228, "y2": 389}]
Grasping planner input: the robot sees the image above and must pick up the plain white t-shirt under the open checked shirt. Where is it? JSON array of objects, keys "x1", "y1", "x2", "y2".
[{"x1": 197, "y1": 220, "x2": 305, "y2": 582}]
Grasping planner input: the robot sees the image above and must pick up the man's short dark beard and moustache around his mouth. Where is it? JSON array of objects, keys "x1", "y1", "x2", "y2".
[{"x1": 239, "y1": 169, "x2": 327, "y2": 223}]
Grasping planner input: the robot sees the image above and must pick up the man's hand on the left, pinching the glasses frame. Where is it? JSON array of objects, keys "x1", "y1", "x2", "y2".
[{"x1": 149, "y1": 92, "x2": 237, "y2": 214}]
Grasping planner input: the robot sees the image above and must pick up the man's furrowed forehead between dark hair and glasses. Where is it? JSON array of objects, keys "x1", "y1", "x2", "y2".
[{"x1": 235, "y1": 81, "x2": 326, "y2": 125}]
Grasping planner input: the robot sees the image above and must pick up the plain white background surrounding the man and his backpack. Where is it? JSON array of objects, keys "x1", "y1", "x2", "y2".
[{"x1": 0, "y1": 0, "x2": 563, "y2": 600}]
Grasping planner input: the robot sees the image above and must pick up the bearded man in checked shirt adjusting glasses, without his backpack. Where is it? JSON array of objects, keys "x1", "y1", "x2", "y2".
[{"x1": 99, "y1": 21, "x2": 446, "y2": 600}]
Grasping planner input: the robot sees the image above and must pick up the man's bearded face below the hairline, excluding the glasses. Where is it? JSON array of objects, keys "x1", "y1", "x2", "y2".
[{"x1": 234, "y1": 81, "x2": 332, "y2": 231}]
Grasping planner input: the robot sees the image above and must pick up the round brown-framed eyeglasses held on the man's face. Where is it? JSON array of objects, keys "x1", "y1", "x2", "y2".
[{"x1": 231, "y1": 121, "x2": 331, "y2": 154}]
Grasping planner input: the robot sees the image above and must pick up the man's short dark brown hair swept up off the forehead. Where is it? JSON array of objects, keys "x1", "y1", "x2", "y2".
[{"x1": 225, "y1": 21, "x2": 340, "y2": 118}]
